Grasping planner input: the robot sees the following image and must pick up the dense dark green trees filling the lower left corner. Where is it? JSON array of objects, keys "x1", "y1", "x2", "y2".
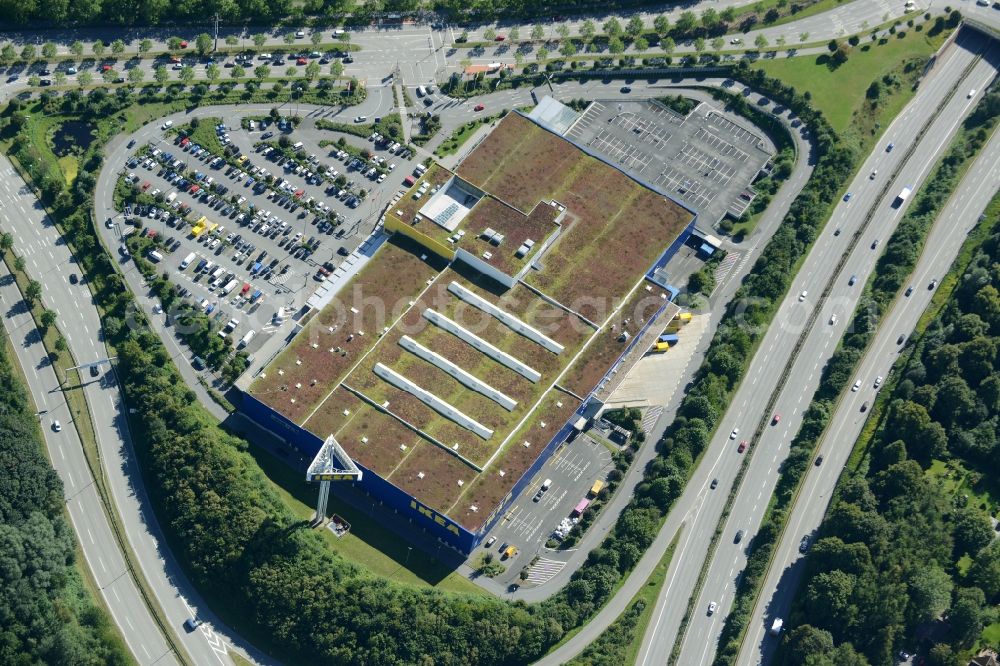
[{"x1": 0, "y1": 316, "x2": 131, "y2": 666}]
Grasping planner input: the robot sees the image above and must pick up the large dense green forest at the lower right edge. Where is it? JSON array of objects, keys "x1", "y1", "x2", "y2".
[{"x1": 785, "y1": 220, "x2": 1000, "y2": 666}]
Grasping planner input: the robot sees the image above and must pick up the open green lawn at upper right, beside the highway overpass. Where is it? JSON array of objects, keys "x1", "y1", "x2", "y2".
[{"x1": 753, "y1": 30, "x2": 947, "y2": 132}]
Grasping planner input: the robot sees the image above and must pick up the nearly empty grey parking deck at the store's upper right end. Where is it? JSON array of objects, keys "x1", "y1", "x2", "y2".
[{"x1": 566, "y1": 100, "x2": 774, "y2": 224}]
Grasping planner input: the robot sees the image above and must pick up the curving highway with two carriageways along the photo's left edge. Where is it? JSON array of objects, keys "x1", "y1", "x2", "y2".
[{"x1": 0, "y1": 156, "x2": 267, "y2": 666}]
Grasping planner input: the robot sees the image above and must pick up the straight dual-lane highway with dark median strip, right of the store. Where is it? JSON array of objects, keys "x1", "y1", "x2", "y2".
[{"x1": 639, "y1": 26, "x2": 993, "y2": 666}]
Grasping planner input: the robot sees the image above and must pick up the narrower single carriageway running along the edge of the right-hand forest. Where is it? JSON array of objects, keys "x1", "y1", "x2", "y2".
[{"x1": 737, "y1": 111, "x2": 1000, "y2": 666}]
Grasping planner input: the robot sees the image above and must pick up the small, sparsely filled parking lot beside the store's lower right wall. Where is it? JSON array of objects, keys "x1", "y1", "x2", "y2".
[{"x1": 483, "y1": 434, "x2": 613, "y2": 585}]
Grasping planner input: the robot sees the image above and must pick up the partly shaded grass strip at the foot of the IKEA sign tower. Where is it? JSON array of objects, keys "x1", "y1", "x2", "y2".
[{"x1": 250, "y1": 438, "x2": 486, "y2": 594}]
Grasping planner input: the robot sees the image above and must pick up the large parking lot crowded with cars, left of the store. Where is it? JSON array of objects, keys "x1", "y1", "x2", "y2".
[{"x1": 104, "y1": 115, "x2": 416, "y2": 364}]
